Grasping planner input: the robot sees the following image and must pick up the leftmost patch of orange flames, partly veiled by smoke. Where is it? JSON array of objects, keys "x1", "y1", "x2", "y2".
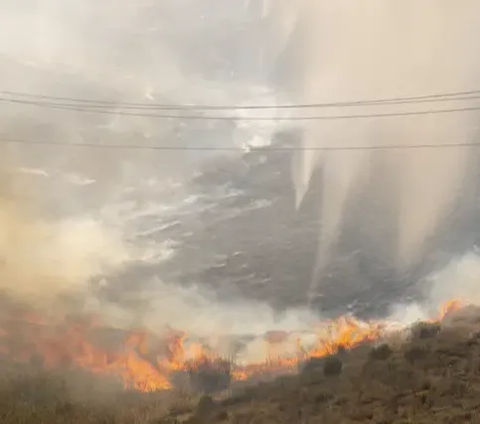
[{"x1": 0, "y1": 318, "x2": 171, "y2": 391}]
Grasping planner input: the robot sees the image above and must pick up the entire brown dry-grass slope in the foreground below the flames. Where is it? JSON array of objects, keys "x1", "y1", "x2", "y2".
[{"x1": 4, "y1": 311, "x2": 480, "y2": 424}]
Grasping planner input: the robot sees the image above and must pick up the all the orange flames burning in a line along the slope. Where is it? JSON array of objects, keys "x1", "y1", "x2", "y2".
[{"x1": 0, "y1": 300, "x2": 463, "y2": 392}]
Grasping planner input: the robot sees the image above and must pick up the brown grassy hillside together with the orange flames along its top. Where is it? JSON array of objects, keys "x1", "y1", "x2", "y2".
[{"x1": 0, "y1": 296, "x2": 472, "y2": 424}]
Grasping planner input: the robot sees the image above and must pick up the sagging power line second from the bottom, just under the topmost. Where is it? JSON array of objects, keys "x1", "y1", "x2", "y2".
[{"x1": 0, "y1": 97, "x2": 480, "y2": 122}]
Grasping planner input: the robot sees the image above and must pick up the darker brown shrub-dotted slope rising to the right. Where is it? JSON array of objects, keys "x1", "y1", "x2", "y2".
[{"x1": 160, "y1": 311, "x2": 480, "y2": 424}]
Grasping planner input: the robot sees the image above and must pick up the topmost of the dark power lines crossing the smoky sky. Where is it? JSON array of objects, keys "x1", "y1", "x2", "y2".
[{"x1": 0, "y1": 90, "x2": 480, "y2": 110}]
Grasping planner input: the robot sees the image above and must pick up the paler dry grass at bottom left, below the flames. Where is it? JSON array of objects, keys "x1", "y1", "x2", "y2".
[{"x1": 0, "y1": 364, "x2": 198, "y2": 424}]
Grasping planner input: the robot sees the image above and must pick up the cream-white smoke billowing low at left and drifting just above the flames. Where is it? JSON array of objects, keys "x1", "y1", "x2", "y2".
[{"x1": 0, "y1": 151, "x2": 318, "y2": 362}]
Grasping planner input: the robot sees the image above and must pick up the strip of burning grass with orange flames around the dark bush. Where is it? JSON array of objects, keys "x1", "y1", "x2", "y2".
[{"x1": 0, "y1": 294, "x2": 428, "y2": 393}]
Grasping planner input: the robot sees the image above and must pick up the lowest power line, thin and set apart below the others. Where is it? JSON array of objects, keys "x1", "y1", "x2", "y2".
[{"x1": 0, "y1": 137, "x2": 480, "y2": 152}]
